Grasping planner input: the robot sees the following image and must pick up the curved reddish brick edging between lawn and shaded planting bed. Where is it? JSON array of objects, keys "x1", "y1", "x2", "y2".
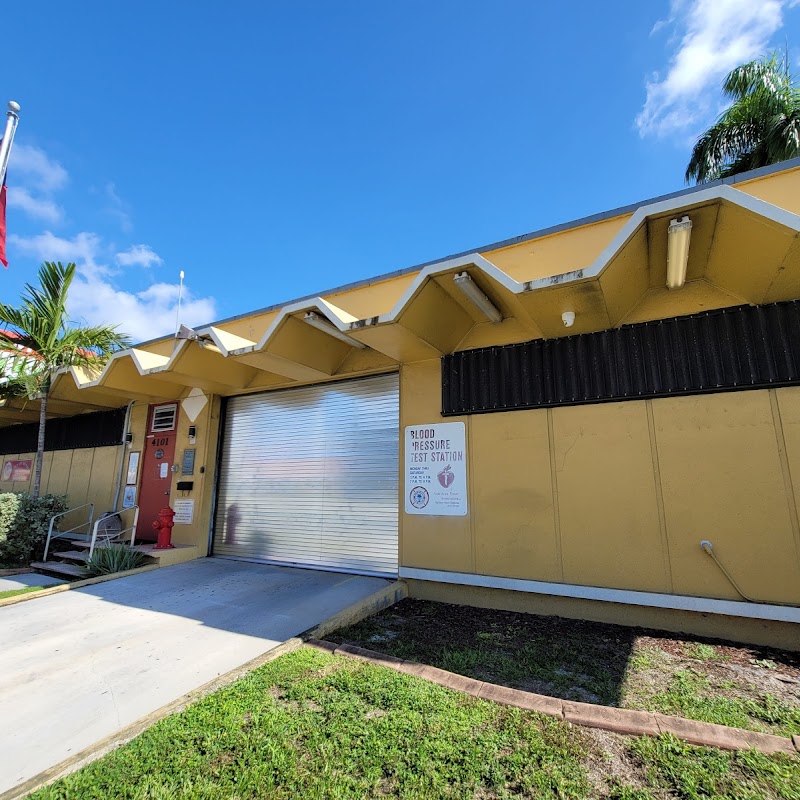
[{"x1": 306, "y1": 639, "x2": 800, "y2": 755}]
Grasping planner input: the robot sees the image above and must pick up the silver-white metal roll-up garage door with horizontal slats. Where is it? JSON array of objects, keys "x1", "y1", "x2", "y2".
[{"x1": 213, "y1": 374, "x2": 399, "y2": 575}]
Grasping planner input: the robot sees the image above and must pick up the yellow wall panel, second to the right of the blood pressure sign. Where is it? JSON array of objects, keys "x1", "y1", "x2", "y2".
[{"x1": 552, "y1": 402, "x2": 669, "y2": 592}]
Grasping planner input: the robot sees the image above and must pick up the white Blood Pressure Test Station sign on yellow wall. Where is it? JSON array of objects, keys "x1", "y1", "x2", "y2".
[{"x1": 405, "y1": 422, "x2": 467, "y2": 517}]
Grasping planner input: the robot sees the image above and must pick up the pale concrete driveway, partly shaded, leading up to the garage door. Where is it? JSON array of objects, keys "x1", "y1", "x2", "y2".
[{"x1": 0, "y1": 558, "x2": 388, "y2": 793}]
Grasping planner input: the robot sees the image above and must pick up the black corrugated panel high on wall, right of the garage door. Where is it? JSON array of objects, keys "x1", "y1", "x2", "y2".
[{"x1": 442, "y1": 300, "x2": 800, "y2": 416}]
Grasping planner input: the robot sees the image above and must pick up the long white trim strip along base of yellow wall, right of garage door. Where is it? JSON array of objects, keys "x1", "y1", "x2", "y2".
[{"x1": 400, "y1": 567, "x2": 800, "y2": 622}]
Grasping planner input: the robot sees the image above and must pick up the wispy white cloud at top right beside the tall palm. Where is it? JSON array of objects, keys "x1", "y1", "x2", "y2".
[{"x1": 636, "y1": 0, "x2": 788, "y2": 136}]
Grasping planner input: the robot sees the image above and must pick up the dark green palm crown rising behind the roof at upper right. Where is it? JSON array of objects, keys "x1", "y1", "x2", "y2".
[{"x1": 686, "y1": 53, "x2": 800, "y2": 183}]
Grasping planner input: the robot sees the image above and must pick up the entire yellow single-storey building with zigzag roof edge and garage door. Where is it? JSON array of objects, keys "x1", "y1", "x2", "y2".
[{"x1": 0, "y1": 159, "x2": 800, "y2": 649}]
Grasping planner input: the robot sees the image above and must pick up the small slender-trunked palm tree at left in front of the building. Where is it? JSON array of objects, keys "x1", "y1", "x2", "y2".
[{"x1": 0, "y1": 261, "x2": 130, "y2": 497}]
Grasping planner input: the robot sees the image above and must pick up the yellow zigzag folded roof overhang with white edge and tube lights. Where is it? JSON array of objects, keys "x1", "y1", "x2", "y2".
[{"x1": 7, "y1": 185, "x2": 800, "y2": 424}]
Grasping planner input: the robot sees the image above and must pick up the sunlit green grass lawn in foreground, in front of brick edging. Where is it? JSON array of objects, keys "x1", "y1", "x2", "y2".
[{"x1": 25, "y1": 648, "x2": 800, "y2": 800}]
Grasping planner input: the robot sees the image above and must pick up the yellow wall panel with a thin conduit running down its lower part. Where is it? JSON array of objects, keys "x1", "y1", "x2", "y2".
[{"x1": 652, "y1": 390, "x2": 800, "y2": 603}]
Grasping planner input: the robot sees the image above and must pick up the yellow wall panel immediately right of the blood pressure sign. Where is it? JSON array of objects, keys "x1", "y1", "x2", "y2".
[{"x1": 469, "y1": 410, "x2": 561, "y2": 581}]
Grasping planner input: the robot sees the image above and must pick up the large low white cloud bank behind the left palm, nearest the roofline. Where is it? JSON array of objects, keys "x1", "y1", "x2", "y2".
[{"x1": 9, "y1": 231, "x2": 216, "y2": 342}]
